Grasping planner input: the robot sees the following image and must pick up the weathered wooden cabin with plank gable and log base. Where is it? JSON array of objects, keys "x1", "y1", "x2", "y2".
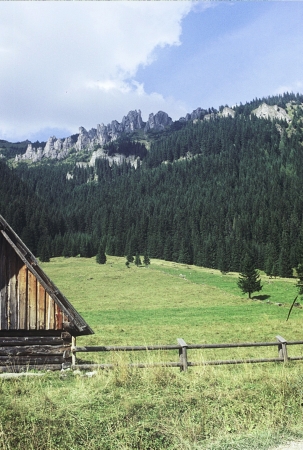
[{"x1": 0, "y1": 216, "x2": 93, "y2": 372}]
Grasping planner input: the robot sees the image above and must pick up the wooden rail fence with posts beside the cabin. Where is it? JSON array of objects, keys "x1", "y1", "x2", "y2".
[{"x1": 71, "y1": 336, "x2": 303, "y2": 371}]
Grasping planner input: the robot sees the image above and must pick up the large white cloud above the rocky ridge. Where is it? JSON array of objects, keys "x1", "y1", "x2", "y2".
[{"x1": 0, "y1": 1, "x2": 192, "y2": 140}]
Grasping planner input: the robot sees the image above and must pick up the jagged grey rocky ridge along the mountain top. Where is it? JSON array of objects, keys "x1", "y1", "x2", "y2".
[{"x1": 0, "y1": 92, "x2": 302, "y2": 164}]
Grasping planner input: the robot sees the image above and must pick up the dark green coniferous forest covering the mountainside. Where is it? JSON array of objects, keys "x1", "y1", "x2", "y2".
[{"x1": 0, "y1": 94, "x2": 303, "y2": 277}]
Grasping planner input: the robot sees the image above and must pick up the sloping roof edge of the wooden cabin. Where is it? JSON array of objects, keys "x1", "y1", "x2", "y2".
[{"x1": 0, "y1": 215, "x2": 94, "y2": 336}]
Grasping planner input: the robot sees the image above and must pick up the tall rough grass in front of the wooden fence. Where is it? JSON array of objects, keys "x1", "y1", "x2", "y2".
[{"x1": 0, "y1": 365, "x2": 303, "y2": 450}]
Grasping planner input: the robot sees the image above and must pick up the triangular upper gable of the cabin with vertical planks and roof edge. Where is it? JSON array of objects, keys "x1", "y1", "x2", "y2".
[{"x1": 0, "y1": 216, "x2": 94, "y2": 336}]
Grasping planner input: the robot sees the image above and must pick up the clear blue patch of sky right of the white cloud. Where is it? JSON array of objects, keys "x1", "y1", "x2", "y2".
[{"x1": 137, "y1": 2, "x2": 303, "y2": 107}]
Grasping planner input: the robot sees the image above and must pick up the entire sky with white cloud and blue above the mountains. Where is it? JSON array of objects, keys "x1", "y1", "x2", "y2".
[{"x1": 0, "y1": 1, "x2": 303, "y2": 141}]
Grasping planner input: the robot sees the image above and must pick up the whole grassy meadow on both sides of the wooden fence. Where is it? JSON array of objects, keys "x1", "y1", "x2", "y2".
[{"x1": 0, "y1": 257, "x2": 303, "y2": 450}]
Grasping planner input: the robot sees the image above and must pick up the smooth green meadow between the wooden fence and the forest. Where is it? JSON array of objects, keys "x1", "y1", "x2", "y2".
[{"x1": 42, "y1": 257, "x2": 302, "y2": 345}]
